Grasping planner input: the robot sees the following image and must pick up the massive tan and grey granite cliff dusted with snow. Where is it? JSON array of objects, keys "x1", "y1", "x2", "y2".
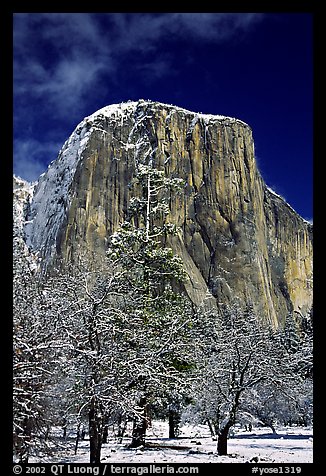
[{"x1": 26, "y1": 101, "x2": 312, "y2": 326}]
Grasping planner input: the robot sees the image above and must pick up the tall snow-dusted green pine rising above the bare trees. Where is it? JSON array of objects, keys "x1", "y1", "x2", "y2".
[{"x1": 110, "y1": 161, "x2": 191, "y2": 447}]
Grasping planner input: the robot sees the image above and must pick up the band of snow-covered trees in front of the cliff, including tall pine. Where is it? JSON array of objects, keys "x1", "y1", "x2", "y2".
[{"x1": 13, "y1": 163, "x2": 312, "y2": 463}]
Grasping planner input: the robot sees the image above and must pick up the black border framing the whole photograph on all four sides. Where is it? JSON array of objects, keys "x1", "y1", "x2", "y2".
[{"x1": 6, "y1": 1, "x2": 325, "y2": 474}]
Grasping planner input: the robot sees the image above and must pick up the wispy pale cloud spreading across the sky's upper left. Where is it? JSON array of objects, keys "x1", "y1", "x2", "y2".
[{"x1": 14, "y1": 13, "x2": 262, "y2": 180}]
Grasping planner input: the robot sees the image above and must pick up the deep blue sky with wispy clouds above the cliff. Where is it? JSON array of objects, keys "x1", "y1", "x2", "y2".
[{"x1": 14, "y1": 13, "x2": 313, "y2": 220}]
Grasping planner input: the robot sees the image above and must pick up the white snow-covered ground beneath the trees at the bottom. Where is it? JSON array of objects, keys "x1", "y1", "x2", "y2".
[{"x1": 31, "y1": 422, "x2": 313, "y2": 463}]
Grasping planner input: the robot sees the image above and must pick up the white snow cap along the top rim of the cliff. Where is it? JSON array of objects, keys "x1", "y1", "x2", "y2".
[{"x1": 85, "y1": 99, "x2": 248, "y2": 126}]
